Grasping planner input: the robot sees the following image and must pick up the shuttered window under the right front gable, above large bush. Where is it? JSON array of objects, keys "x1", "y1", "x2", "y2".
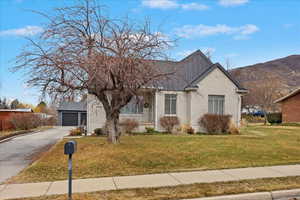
[{"x1": 208, "y1": 95, "x2": 225, "y2": 115}]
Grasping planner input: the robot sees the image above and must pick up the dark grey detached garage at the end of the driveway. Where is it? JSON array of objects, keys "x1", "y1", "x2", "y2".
[{"x1": 57, "y1": 102, "x2": 87, "y2": 126}]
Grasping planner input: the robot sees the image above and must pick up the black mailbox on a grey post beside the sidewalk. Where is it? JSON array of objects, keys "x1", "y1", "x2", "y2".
[{"x1": 64, "y1": 140, "x2": 77, "y2": 200}]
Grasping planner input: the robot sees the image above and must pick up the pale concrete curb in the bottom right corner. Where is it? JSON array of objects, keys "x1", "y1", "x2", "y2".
[{"x1": 182, "y1": 189, "x2": 300, "y2": 200}]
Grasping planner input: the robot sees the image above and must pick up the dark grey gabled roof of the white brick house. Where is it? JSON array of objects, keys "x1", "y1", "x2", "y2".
[{"x1": 151, "y1": 50, "x2": 245, "y2": 91}]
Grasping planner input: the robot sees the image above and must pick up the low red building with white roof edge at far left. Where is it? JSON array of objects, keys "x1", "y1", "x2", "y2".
[{"x1": 0, "y1": 108, "x2": 33, "y2": 130}]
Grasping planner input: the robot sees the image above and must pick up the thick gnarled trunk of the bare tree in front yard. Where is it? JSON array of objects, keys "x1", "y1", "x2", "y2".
[{"x1": 106, "y1": 113, "x2": 120, "y2": 144}]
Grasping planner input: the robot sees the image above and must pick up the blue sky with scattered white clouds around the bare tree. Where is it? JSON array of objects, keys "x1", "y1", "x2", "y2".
[{"x1": 0, "y1": 0, "x2": 300, "y2": 104}]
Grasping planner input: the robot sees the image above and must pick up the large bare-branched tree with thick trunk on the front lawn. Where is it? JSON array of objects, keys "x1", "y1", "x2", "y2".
[{"x1": 15, "y1": 0, "x2": 173, "y2": 143}]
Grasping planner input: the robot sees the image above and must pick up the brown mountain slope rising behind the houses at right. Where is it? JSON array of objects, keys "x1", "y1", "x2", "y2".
[{"x1": 230, "y1": 55, "x2": 300, "y2": 93}]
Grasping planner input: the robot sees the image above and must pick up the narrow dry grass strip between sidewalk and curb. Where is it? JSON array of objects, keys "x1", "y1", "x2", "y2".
[{"x1": 8, "y1": 177, "x2": 300, "y2": 200}]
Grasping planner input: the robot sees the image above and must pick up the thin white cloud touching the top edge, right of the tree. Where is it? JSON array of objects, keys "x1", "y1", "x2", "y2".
[{"x1": 142, "y1": 0, "x2": 209, "y2": 10}]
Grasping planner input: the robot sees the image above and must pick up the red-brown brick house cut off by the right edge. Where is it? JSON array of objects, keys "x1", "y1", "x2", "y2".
[{"x1": 275, "y1": 88, "x2": 300, "y2": 123}]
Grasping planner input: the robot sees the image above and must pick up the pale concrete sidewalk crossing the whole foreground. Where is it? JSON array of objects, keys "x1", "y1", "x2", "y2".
[{"x1": 0, "y1": 165, "x2": 300, "y2": 199}]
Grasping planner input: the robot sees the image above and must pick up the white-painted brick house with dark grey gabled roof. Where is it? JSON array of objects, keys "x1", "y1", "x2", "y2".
[{"x1": 87, "y1": 50, "x2": 247, "y2": 133}]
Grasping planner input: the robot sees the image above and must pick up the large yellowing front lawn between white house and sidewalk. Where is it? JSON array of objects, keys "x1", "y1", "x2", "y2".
[{"x1": 11, "y1": 125, "x2": 300, "y2": 183}]
